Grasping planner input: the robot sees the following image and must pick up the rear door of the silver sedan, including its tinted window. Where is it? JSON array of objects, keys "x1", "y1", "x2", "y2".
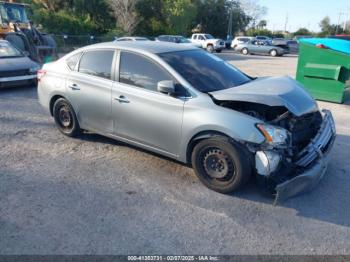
[{"x1": 66, "y1": 50, "x2": 115, "y2": 133}]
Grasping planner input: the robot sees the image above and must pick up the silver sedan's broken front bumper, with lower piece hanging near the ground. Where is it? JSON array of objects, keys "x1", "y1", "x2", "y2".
[{"x1": 275, "y1": 110, "x2": 336, "y2": 204}]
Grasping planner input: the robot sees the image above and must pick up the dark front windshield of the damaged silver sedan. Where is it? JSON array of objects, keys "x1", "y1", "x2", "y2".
[{"x1": 159, "y1": 50, "x2": 251, "y2": 93}]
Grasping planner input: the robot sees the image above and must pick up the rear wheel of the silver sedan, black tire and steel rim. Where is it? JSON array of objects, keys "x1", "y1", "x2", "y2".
[{"x1": 52, "y1": 98, "x2": 81, "y2": 137}]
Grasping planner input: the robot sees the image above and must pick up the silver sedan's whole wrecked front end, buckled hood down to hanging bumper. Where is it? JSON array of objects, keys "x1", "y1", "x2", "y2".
[{"x1": 210, "y1": 77, "x2": 336, "y2": 203}]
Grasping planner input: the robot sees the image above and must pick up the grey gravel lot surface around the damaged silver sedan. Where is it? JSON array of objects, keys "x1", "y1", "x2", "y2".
[{"x1": 0, "y1": 52, "x2": 350, "y2": 255}]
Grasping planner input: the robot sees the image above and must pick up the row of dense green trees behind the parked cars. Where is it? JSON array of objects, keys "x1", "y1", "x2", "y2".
[{"x1": 19, "y1": 0, "x2": 266, "y2": 38}]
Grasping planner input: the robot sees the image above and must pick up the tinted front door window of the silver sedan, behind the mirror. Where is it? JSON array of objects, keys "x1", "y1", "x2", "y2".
[{"x1": 119, "y1": 52, "x2": 174, "y2": 92}]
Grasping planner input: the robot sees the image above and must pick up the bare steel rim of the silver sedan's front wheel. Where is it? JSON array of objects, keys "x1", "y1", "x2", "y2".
[{"x1": 203, "y1": 149, "x2": 234, "y2": 179}]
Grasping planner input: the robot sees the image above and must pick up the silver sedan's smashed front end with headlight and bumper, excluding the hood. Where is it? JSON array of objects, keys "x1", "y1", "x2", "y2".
[{"x1": 216, "y1": 97, "x2": 336, "y2": 204}]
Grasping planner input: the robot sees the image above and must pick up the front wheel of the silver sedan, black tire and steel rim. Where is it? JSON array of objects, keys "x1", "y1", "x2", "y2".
[{"x1": 192, "y1": 136, "x2": 252, "y2": 194}]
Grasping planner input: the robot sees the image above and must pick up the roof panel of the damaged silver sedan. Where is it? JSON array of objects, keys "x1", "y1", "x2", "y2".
[{"x1": 82, "y1": 41, "x2": 198, "y2": 54}]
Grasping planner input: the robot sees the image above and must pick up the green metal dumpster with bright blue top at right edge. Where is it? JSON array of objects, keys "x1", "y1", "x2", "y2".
[{"x1": 296, "y1": 38, "x2": 350, "y2": 103}]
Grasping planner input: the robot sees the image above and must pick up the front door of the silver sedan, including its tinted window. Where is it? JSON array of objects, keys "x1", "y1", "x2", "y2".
[{"x1": 112, "y1": 51, "x2": 184, "y2": 156}]
